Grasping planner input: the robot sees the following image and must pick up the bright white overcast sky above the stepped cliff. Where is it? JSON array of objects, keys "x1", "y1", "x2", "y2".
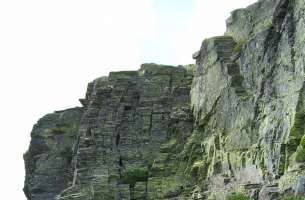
[{"x1": 0, "y1": 0, "x2": 256, "y2": 200}]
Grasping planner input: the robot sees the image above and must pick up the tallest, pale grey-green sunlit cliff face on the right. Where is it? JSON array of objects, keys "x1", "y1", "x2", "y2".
[{"x1": 191, "y1": 0, "x2": 304, "y2": 198}]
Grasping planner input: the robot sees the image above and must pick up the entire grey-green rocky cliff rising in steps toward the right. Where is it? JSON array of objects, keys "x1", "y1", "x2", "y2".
[{"x1": 24, "y1": 0, "x2": 305, "y2": 200}]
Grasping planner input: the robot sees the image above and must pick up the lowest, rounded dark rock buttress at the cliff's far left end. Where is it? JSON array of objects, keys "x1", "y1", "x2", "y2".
[{"x1": 24, "y1": 108, "x2": 83, "y2": 200}]
